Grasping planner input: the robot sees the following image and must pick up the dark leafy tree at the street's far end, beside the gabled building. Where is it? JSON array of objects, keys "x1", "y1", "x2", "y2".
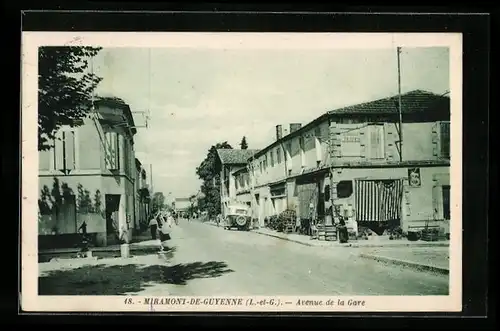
[{"x1": 196, "y1": 141, "x2": 233, "y2": 217}]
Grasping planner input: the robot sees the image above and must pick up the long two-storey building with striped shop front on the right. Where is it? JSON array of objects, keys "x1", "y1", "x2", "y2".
[{"x1": 244, "y1": 90, "x2": 450, "y2": 236}]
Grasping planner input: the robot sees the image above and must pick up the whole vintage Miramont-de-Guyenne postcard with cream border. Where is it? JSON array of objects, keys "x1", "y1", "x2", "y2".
[{"x1": 21, "y1": 32, "x2": 462, "y2": 312}]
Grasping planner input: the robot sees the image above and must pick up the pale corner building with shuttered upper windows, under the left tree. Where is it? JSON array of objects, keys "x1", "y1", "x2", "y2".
[{"x1": 38, "y1": 98, "x2": 136, "y2": 249}]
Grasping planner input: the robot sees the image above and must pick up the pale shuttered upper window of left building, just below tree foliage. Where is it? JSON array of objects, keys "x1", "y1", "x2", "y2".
[{"x1": 52, "y1": 129, "x2": 76, "y2": 171}]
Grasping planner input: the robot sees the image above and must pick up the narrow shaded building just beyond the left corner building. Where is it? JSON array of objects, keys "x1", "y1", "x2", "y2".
[{"x1": 134, "y1": 158, "x2": 151, "y2": 230}]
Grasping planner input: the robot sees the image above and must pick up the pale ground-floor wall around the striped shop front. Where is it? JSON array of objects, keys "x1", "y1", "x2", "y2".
[{"x1": 331, "y1": 166, "x2": 450, "y2": 232}]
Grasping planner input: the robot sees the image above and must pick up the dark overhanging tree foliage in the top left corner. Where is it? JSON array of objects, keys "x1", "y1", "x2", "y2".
[{"x1": 38, "y1": 46, "x2": 102, "y2": 151}]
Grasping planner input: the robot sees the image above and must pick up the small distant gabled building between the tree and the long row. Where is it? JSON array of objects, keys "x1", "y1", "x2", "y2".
[{"x1": 217, "y1": 149, "x2": 258, "y2": 216}]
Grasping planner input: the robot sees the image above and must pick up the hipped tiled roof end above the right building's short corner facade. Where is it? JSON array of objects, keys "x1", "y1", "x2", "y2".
[{"x1": 328, "y1": 90, "x2": 450, "y2": 114}]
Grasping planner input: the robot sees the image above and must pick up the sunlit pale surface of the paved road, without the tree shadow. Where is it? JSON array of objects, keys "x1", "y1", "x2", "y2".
[{"x1": 145, "y1": 221, "x2": 448, "y2": 295}]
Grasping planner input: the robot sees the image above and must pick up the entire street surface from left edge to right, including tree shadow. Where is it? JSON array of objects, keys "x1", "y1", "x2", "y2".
[{"x1": 39, "y1": 220, "x2": 448, "y2": 296}]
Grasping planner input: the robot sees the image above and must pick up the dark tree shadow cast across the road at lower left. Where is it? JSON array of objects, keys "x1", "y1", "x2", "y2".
[{"x1": 38, "y1": 261, "x2": 233, "y2": 295}]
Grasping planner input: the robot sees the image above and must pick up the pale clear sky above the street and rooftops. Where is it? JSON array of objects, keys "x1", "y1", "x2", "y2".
[{"x1": 93, "y1": 47, "x2": 450, "y2": 199}]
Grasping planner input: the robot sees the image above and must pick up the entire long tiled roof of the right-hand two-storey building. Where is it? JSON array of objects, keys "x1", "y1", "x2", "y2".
[{"x1": 252, "y1": 90, "x2": 450, "y2": 161}]
